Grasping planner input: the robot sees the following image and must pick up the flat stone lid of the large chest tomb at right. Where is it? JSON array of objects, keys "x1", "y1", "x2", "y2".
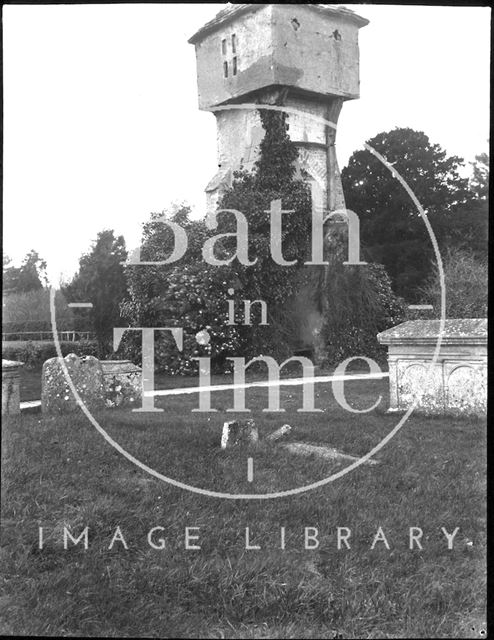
[{"x1": 378, "y1": 318, "x2": 487, "y2": 344}]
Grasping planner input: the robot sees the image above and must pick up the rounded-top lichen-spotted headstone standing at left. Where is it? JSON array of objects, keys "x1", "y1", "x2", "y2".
[{"x1": 41, "y1": 353, "x2": 105, "y2": 413}]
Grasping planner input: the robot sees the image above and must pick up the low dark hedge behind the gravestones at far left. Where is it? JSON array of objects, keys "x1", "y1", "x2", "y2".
[{"x1": 2, "y1": 340, "x2": 97, "y2": 369}]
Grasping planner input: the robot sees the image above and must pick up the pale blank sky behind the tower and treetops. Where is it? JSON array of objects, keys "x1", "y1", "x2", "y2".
[{"x1": 3, "y1": 4, "x2": 490, "y2": 285}]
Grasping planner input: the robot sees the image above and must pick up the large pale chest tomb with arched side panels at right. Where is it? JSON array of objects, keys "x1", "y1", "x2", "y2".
[{"x1": 377, "y1": 319, "x2": 487, "y2": 415}]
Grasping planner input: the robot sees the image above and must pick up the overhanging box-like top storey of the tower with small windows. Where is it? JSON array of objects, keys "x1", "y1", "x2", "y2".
[{"x1": 189, "y1": 3, "x2": 368, "y2": 109}]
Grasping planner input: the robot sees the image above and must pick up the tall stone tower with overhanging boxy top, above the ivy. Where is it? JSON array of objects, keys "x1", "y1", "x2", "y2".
[{"x1": 189, "y1": 4, "x2": 368, "y2": 211}]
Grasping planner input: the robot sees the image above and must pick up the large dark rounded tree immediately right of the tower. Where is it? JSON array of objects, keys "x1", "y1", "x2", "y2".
[{"x1": 342, "y1": 128, "x2": 474, "y2": 301}]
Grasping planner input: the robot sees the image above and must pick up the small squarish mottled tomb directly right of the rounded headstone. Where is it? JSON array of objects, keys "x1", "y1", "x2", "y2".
[{"x1": 101, "y1": 360, "x2": 142, "y2": 407}]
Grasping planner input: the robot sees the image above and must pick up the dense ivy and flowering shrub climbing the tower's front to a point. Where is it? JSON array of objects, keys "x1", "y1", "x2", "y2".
[{"x1": 122, "y1": 109, "x2": 311, "y2": 374}]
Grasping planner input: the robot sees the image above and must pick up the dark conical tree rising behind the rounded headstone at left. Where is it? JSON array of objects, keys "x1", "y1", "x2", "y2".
[{"x1": 63, "y1": 229, "x2": 127, "y2": 357}]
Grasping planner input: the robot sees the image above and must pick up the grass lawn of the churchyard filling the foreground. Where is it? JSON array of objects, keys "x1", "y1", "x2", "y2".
[{"x1": 0, "y1": 380, "x2": 486, "y2": 638}]
